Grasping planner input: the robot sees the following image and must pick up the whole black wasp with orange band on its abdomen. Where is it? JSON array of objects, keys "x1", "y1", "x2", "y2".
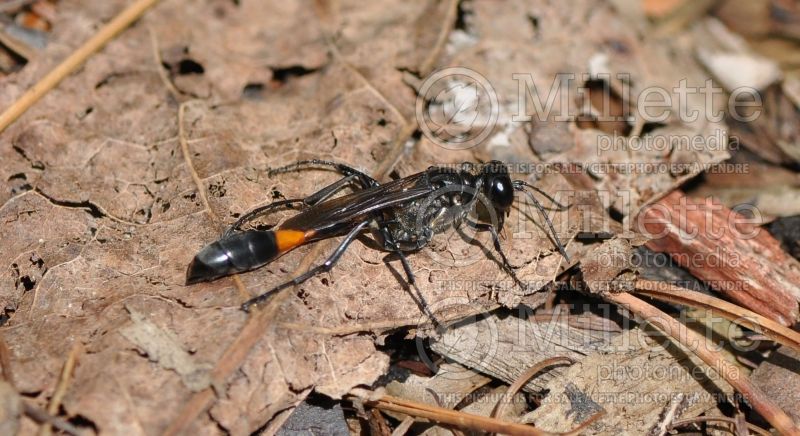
[{"x1": 186, "y1": 159, "x2": 569, "y2": 310}]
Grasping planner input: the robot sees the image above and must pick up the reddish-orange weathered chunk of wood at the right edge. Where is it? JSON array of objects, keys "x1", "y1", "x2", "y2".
[{"x1": 636, "y1": 191, "x2": 800, "y2": 325}]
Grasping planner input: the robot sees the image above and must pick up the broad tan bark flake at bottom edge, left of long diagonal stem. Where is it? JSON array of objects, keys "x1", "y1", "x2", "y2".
[{"x1": 522, "y1": 329, "x2": 733, "y2": 435}]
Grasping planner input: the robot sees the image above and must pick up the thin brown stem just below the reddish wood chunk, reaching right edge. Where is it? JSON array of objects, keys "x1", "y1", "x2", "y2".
[{"x1": 636, "y1": 280, "x2": 800, "y2": 352}]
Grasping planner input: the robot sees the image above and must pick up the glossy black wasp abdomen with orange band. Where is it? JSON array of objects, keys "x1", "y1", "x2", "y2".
[{"x1": 186, "y1": 230, "x2": 306, "y2": 284}]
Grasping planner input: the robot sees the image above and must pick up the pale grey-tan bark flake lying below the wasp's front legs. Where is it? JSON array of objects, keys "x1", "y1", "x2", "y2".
[{"x1": 431, "y1": 316, "x2": 618, "y2": 393}]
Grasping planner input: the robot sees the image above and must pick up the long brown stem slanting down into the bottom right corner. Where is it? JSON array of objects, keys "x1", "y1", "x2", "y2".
[{"x1": 603, "y1": 293, "x2": 800, "y2": 436}]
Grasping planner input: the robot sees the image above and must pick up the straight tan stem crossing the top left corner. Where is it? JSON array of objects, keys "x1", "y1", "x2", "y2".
[{"x1": 0, "y1": 0, "x2": 159, "y2": 132}]
